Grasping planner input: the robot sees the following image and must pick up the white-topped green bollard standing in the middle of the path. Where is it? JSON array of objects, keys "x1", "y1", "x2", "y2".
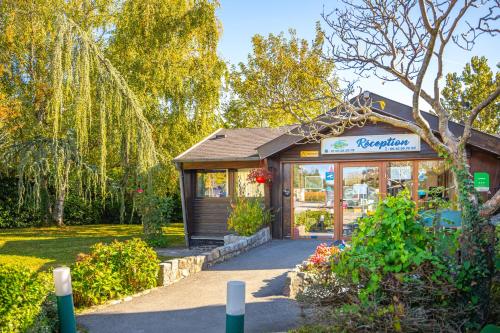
[{"x1": 226, "y1": 281, "x2": 245, "y2": 333}]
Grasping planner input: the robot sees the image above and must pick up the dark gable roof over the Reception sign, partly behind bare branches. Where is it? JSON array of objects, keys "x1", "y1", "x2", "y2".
[{"x1": 258, "y1": 92, "x2": 500, "y2": 159}]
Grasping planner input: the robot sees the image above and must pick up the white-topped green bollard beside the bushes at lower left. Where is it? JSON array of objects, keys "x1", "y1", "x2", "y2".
[{"x1": 53, "y1": 267, "x2": 76, "y2": 333}]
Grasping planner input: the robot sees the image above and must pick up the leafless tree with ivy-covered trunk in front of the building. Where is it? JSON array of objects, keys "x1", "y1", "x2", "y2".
[{"x1": 284, "y1": 0, "x2": 500, "y2": 321}]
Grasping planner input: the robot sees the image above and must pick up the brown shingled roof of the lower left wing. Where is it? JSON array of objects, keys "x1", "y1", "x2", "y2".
[{"x1": 174, "y1": 126, "x2": 291, "y2": 162}]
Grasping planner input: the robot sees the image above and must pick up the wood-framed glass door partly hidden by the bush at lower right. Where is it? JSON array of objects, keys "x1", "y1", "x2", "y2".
[{"x1": 336, "y1": 162, "x2": 382, "y2": 238}]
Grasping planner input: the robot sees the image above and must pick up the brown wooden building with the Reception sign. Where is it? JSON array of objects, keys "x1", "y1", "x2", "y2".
[{"x1": 174, "y1": 93, "x2": 500, "y2": 243}]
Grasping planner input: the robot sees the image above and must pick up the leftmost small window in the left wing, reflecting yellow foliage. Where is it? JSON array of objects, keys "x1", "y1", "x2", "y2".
[{"x1": 196, "y1": 170, "x2": 227, "y2": 198}]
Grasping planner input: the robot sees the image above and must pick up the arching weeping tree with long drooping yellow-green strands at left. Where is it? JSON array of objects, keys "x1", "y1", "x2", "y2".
[{"x1": 2, "y1": 16, "x2": 157, "y2": 223}]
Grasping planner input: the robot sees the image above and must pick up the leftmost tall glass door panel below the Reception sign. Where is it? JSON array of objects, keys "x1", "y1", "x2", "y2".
[{"x1": 292, "y1": 163, "x2": 335, "y2": 238}]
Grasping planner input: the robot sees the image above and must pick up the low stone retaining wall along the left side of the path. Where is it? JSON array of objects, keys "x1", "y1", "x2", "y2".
[{"x1": 158, "y1": 227, "x2": 271, "y2": 286}]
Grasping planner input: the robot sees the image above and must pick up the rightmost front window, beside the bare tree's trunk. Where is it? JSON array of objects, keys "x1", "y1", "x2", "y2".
[{"x1": 417, "y1": 161, "x2": 455, "y2": 209}]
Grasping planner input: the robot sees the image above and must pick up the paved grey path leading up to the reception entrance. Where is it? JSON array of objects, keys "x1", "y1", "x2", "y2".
[{"x1": 78, "y1": 240, "x2": 320, "y2": 333}]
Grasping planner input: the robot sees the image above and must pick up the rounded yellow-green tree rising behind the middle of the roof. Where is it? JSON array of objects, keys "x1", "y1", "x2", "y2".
[{"x1": 228, "y1": 26, "x2": 336, "y2": 127}]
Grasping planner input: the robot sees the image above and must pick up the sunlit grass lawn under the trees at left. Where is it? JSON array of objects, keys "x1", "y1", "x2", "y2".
[{"x1": 0, "y1": 223, "x2": 184, "y2": 271}]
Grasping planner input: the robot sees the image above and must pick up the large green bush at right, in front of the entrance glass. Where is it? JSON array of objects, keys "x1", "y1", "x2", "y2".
[{"x1": 299, "y1": 191, "x2": 477, "y2": 332}]
